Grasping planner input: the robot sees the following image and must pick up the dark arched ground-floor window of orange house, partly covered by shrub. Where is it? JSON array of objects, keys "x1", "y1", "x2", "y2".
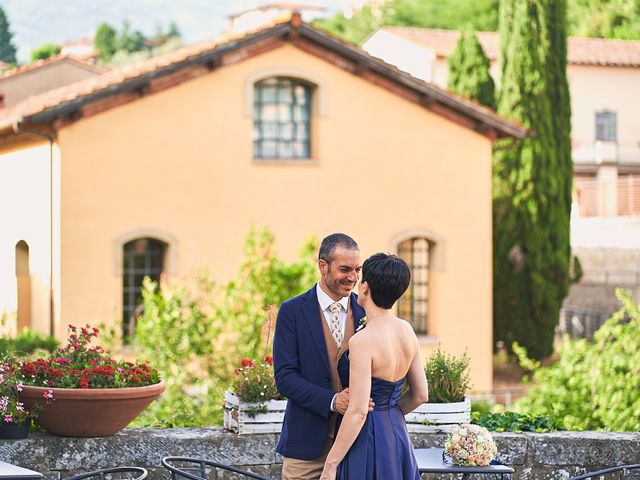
[{"x1": 122, "y1": 238, "x2": 166, "y2": 341}]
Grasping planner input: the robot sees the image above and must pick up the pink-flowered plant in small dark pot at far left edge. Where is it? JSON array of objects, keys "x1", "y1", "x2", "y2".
[{"x1": 0, "y1": 358, "x2": 42, "y2": 439}]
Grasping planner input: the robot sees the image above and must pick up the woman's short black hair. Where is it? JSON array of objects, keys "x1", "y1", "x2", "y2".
[{"x1": 362, "y1": 253, "x2": 411, "y2": 308}]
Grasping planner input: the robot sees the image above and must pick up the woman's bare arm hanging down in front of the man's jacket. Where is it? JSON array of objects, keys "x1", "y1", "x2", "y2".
[{"x1": 320, "y1": 334, "x2": 371, "y2": 480}]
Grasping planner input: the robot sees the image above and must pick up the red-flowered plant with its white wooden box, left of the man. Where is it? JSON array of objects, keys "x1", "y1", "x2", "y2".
[{"x1": 224, "y1": 355, "x2": 287, "y2": 434}]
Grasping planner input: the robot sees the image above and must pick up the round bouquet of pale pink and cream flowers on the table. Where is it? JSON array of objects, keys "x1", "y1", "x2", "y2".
[{"x1": 444, "y1": 424, "x2": 498, "y2": 467}]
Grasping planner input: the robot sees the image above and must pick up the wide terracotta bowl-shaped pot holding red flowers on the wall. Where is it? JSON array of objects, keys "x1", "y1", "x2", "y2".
[{"x1": 20, "y1": 382, "x2": 165, "y2": 437}]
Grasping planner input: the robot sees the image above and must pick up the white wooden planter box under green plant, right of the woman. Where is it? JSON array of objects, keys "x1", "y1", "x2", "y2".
[{"x1": 404, "y1": 397, "x2": 471, "y2": 432}]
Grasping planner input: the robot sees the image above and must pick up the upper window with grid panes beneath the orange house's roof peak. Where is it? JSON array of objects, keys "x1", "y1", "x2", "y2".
[{"x1": 253, "y1": 77, "x2": 312, "y2": 159}]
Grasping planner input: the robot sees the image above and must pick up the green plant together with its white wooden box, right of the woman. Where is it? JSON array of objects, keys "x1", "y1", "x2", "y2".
[{"x1": 405, "y1": 349, "x2": 471, "y2": 432}]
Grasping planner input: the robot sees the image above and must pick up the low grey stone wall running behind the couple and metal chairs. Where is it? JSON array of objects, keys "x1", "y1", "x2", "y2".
[{"x1": 0, "y1": 427, "x2": 640, "y2": 480}]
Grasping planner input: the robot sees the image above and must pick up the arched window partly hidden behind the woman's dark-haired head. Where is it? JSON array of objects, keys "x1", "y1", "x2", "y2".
[{"x1": 398, "y1": 237, "x2": 429, "y2": 334}]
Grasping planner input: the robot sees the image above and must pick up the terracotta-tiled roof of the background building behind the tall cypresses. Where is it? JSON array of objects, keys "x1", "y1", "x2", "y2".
[{"x1": 382, "y1": 27, "x2": 640, "y2": 67}]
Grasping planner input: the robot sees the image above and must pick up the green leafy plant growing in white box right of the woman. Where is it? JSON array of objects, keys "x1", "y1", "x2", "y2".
[{"x1": 425, "y1": 349, "x2": 470, "y2": 403}]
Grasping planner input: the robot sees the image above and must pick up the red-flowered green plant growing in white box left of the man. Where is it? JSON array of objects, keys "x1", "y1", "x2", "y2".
[{"x1": 232, "y1": 355, "x2": 283, "y2": 402}]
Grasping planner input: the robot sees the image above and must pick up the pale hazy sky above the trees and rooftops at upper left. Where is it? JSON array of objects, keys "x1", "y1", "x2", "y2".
[{"x1": 0, "y1": 0, "x2": 344, "y2": 62}]
